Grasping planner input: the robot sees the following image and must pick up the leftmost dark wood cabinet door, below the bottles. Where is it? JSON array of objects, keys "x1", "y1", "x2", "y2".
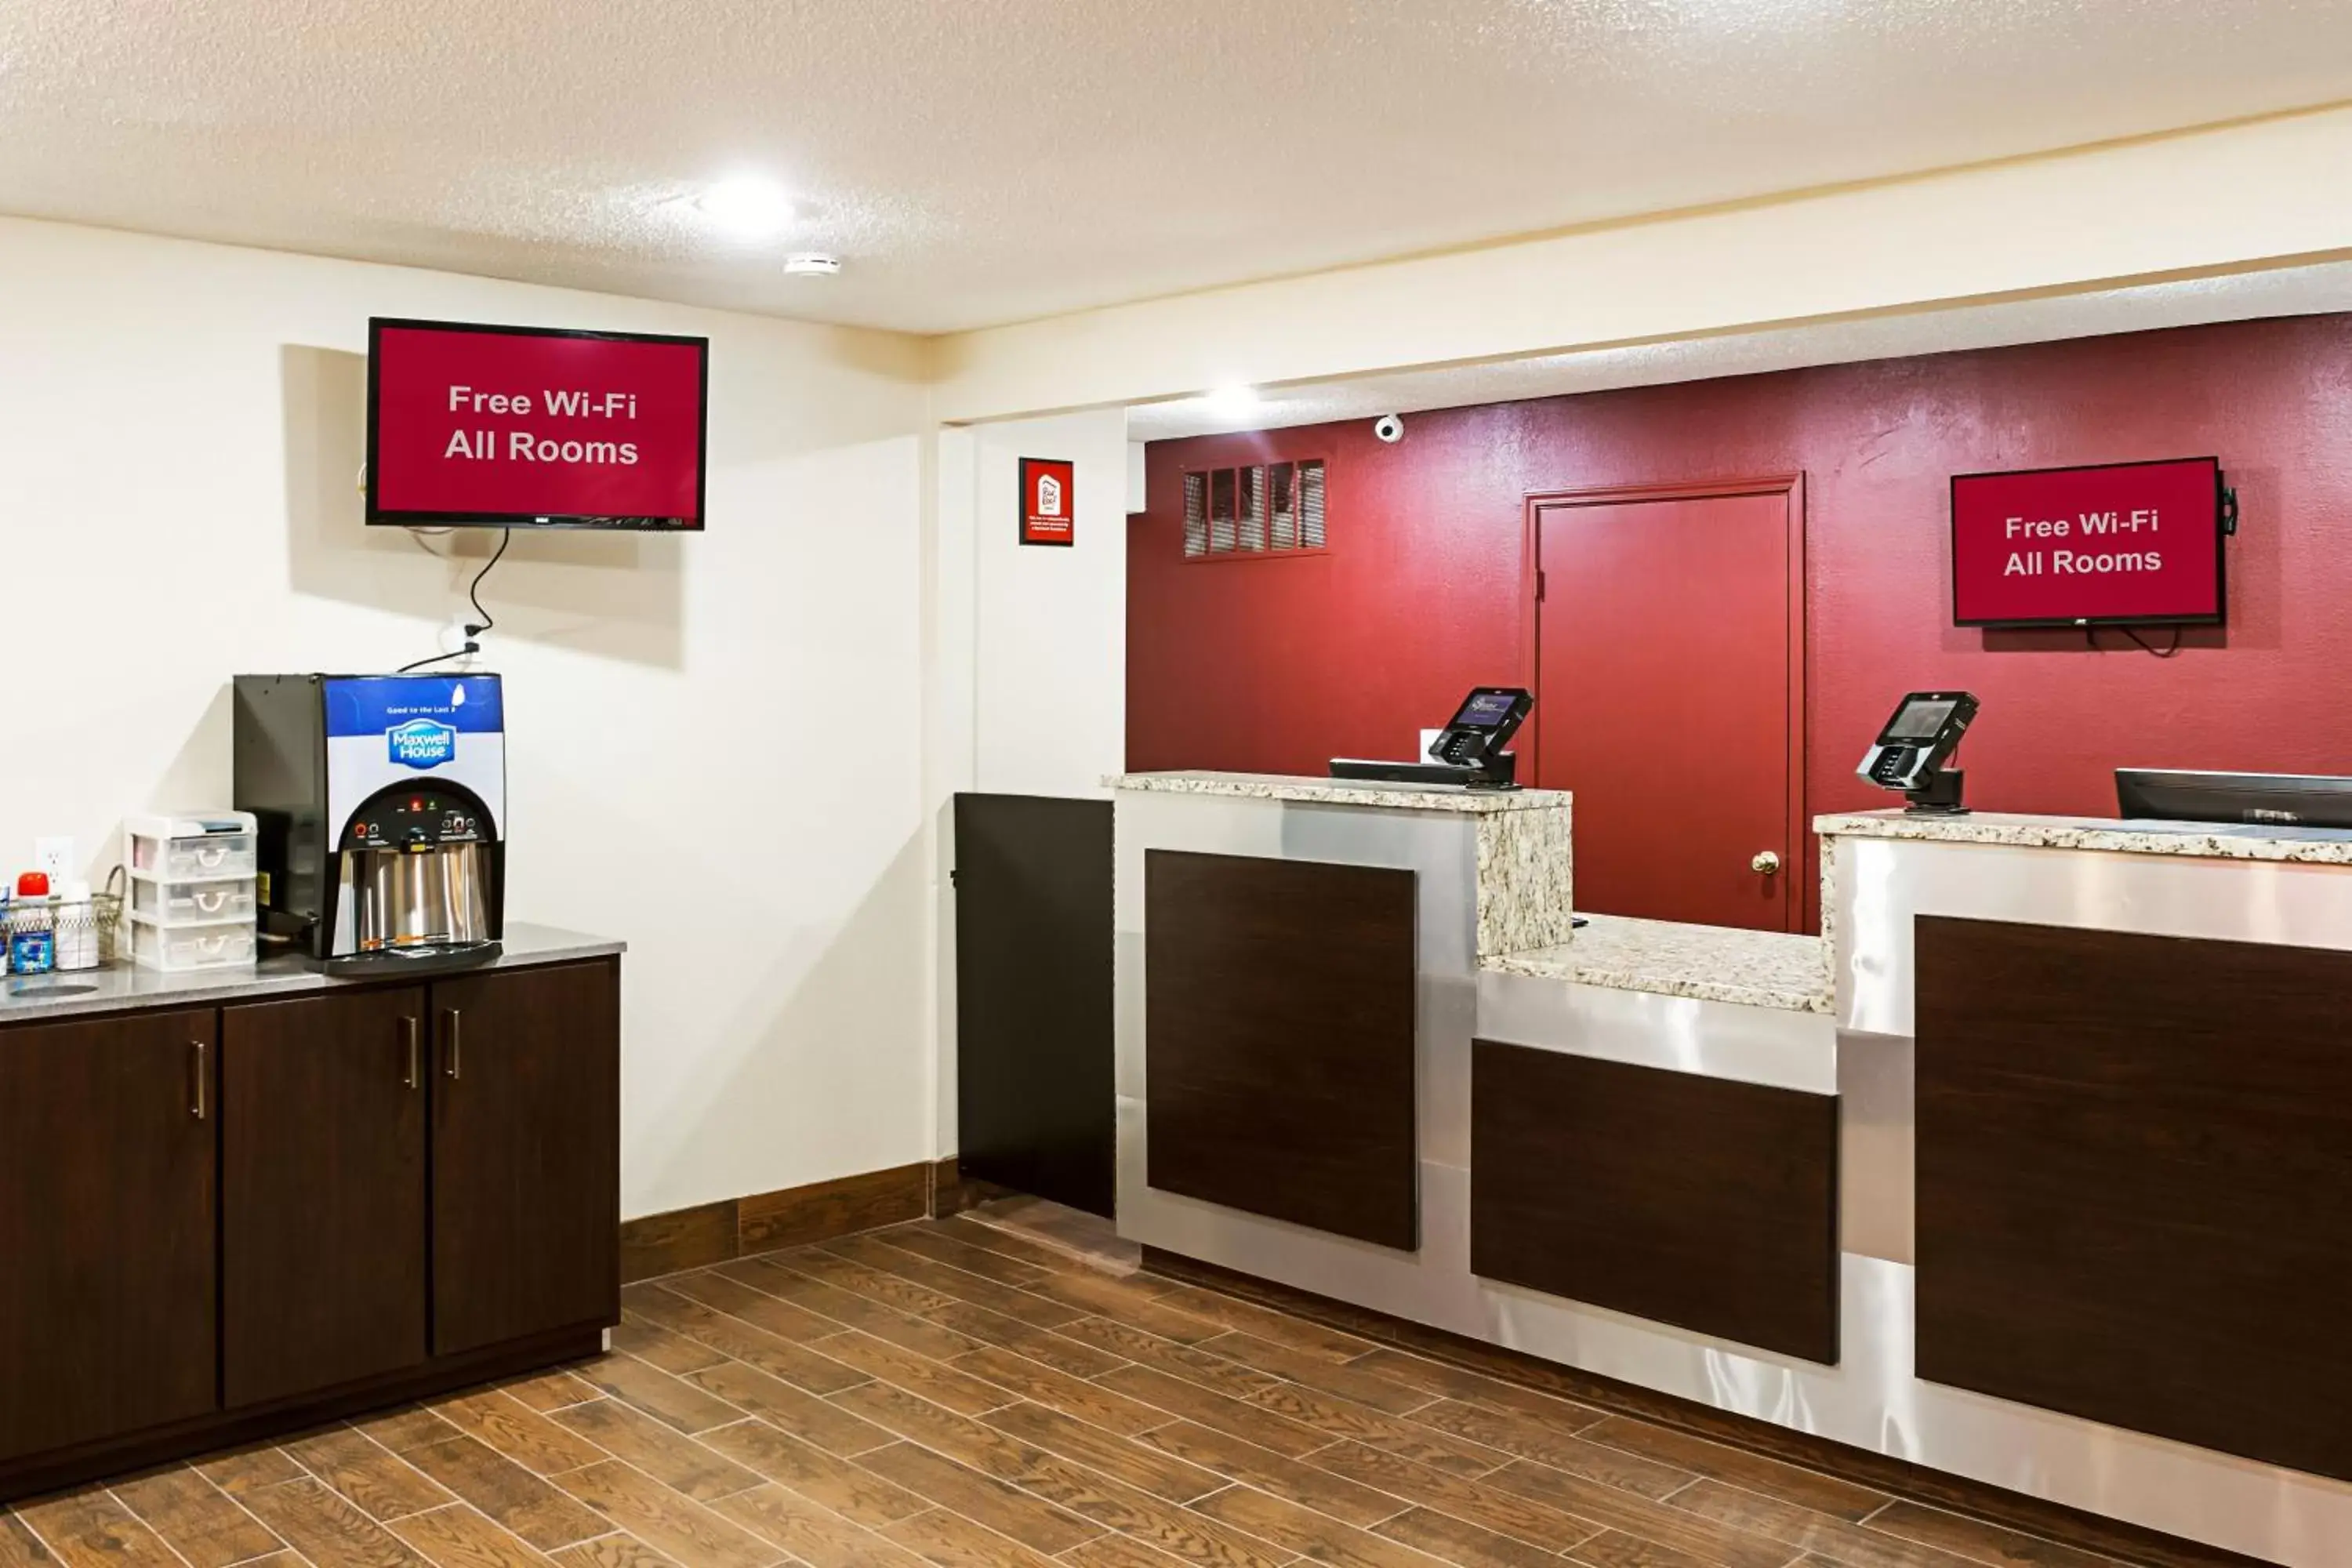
[{"x1": 0, "y1": 1008, "x2": 219, "y2": 1460}]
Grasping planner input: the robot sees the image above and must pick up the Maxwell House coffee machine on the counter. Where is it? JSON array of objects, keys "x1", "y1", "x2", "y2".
[{"x1": 235, "y1": 675, "x2": 506, "y2": 978}]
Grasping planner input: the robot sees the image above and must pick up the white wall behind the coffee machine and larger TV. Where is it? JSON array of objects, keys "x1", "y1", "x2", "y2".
[{"x1": 0, "y1": 221, "x2": 936, "y2": 1215}]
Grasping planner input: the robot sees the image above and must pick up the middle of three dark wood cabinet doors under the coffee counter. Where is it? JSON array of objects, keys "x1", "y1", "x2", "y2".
[{"x1": 221, "y1": 985, "x2": 426, "y2": 1408}]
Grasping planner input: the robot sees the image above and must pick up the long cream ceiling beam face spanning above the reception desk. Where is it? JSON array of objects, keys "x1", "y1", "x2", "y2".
[{"x1": 934, "y1": 106, "x2": 2352, "y2": 421}]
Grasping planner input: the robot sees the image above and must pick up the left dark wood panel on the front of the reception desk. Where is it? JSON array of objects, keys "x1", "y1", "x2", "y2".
[{"x1": 1143, "y1": 848, "x2": 1421, "y2": 1248}]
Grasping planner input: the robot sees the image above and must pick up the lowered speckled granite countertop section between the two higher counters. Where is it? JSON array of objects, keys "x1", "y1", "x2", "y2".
[{"x1": 1482, "y1": 914, "x2": 1832, "y2": 1013}]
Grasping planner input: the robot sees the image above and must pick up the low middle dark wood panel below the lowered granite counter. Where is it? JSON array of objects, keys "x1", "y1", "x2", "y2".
[{"x1": 1470, "y1": 1039, "x2": 1837, "y2": 1363}]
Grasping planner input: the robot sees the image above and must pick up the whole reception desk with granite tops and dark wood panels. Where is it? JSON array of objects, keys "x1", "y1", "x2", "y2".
[{"x1": 1112, "y1": 776, "x2": 2352, "y2": 1568}]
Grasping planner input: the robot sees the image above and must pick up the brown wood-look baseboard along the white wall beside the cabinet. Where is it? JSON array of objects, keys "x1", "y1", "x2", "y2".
[{"x1": 621, "y1": 1154, "x2": 993, "y2": 1283}]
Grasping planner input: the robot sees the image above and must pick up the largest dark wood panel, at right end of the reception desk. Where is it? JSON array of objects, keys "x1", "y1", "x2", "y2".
[{"x1": 1917, "y1": 916, "x2": 2352, "y2": 1479}]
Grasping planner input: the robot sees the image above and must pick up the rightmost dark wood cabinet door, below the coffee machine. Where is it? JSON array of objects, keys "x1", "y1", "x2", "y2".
[{"x1": 433, "y1": 959, "x2": 621, "y2": 1356}]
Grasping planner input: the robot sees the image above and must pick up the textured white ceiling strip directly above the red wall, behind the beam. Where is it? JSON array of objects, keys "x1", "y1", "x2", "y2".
[{"x1": 1127, "y1": 261, "x2": 2352, "y2": 442}]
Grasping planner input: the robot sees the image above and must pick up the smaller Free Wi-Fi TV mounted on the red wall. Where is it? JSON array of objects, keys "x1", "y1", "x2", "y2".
[{"x1": 1952, "y1": 459, "x2": 2230, "y2": 626}]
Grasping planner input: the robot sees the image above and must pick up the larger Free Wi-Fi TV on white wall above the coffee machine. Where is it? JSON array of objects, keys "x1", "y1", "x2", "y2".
[{"x1": 367, "y1": 318, "x2": 710, "y2": 529}]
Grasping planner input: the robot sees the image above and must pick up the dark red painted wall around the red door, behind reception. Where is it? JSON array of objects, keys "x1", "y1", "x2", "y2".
[{"x1": 1127, "y1": 315, "x2": 2352, "y2": 926}]
